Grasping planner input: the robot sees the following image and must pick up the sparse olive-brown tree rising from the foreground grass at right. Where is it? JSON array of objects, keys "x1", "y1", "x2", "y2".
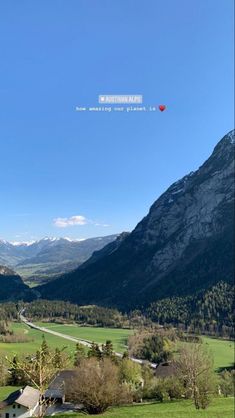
[{"x1": 175, "y1": 344, "x2": 216, "y2": 409}]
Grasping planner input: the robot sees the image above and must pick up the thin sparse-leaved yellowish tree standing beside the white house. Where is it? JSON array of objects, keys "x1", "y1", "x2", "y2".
[{"x1": 8, "y1": 337, "x2": 67, "y2": 418}]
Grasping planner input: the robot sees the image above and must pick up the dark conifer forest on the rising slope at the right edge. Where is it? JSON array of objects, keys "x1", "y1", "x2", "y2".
[{"x1": 146, "y1": 282, "x2": 234, "y2": 338}]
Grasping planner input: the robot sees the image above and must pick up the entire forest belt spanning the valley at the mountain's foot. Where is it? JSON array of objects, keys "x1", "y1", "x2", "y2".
[{"x1": 0, "y1": 282, "x2": 234, "y2": 339}]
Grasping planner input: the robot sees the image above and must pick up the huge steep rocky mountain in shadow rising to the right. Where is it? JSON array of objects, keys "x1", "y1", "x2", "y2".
[{"x1": 38, "y1": 131, "x2": 235, "y2": 309}]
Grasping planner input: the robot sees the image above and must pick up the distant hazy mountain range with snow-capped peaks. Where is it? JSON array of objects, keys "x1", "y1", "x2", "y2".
[{"x1": 0, "y1": 235, "x2": 117, "y2": 284}]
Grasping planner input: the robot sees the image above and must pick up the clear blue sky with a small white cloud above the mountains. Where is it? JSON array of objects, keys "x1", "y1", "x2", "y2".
[{"x1": 0, "y1": 0, "x2": 234, "y2": 241}]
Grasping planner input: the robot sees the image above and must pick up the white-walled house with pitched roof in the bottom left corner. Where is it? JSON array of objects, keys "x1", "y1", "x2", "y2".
[{"x1": 0, "y1": 386, "x2": 39, "y2": 418}]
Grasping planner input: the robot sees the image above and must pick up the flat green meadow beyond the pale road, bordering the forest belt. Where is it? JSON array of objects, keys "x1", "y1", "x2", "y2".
[{"x1": 36, "y1": 322, "x2": 133, "y2": 353}]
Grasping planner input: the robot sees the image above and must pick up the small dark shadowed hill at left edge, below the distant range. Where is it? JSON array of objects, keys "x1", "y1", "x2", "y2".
[{"x1": 0, "y1": 266, "x2": 34, "y2": 302}]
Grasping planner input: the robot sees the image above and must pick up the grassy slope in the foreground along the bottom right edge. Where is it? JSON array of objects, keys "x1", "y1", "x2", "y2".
[{"x1": 53, "y1": 398, "x2": 234, "y2": 418}]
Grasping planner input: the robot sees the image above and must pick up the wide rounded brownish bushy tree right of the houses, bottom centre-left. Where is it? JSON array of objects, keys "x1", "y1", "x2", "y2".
[{"x1": 68, "y1": 357, "x2": 132, "y2": 414}]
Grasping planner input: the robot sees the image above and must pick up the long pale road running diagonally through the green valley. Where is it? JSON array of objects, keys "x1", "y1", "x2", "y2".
[{"x1": 19, "y1": 310, "x2": 157, "y2": 369}]
